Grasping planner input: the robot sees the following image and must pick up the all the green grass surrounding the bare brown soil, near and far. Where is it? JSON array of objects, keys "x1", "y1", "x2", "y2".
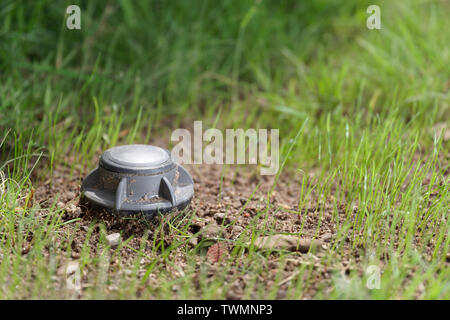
[{"x1": 0, "y1": 0, "x2": 450, "y2": 299}]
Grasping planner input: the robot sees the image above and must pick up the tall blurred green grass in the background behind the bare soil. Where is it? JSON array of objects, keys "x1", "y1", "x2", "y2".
[{"x1": 0, "y1": 0, "x2": 450, "y2": 174}]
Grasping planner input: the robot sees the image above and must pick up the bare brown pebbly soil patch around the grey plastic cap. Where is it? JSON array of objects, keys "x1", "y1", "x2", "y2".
[{"x1": 29, "y1": 152, "x2": 446, "y2": 299}]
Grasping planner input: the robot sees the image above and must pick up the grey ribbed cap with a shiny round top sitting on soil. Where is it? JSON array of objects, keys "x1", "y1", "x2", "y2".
[{"x1": 81, "y1": 144, "x2": 194, "y2": 219}]
